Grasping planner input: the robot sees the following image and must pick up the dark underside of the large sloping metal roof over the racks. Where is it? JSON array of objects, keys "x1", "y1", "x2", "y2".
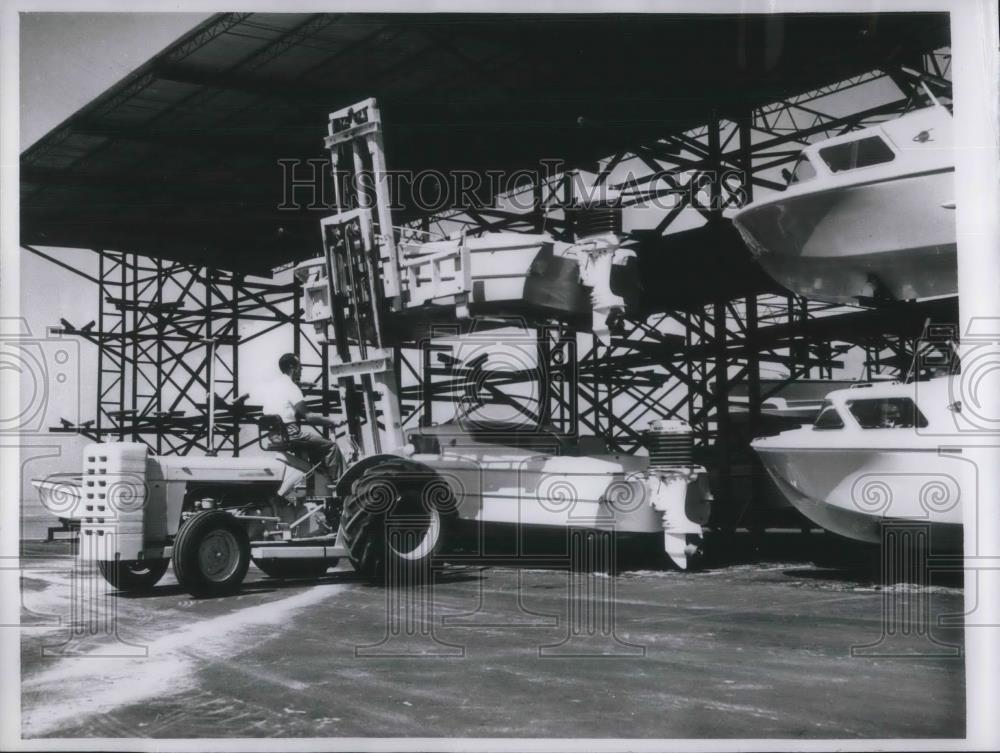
[{"x1": 21, "y1": 13, "x2": 948, "y2": 271}]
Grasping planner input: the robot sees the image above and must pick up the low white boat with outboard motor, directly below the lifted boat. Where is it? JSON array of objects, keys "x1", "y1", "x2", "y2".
[{"x1": 407, "y1": 414, "x2": 713, "y2": 569}]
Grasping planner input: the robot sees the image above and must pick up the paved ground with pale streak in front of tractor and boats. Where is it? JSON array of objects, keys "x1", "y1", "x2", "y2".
[{"x1": 22, "y1": 544, "x2": 965, "y2": 738}]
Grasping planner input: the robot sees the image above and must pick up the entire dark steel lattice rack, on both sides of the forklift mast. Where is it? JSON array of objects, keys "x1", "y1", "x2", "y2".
[{"x1": 29, "y1": 38, "x2": 950, "y2": 524}]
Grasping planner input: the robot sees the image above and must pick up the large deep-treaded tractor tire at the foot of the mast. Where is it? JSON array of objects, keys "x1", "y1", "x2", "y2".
[{"x1": 340, "y1": 463, "x2": 450, "y2": 585}]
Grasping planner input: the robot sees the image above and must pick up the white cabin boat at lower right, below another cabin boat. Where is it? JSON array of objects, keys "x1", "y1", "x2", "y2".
[{"x1": 751, "y1": 377, "x2": 964, "y2": 549}]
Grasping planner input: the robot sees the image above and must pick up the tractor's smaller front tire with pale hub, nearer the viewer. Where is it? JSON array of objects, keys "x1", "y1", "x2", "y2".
[{"x1": 174, "y1": 510, "x2": 250, "y2": 596}]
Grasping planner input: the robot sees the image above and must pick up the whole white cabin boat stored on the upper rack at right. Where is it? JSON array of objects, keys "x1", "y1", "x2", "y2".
[{"x1": 733, "y1": 104, "x2": 958, "y2": 304}]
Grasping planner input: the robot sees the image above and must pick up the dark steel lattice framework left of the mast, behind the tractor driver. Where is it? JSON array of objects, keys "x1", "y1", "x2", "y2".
[{"x1": 27, "y1": 247, "x2": 339, "y2": 455}]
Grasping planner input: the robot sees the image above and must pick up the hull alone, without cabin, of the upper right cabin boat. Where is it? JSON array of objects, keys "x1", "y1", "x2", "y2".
[{"x1": 733, "y1": 169, "x2": 958, "y2": 303}]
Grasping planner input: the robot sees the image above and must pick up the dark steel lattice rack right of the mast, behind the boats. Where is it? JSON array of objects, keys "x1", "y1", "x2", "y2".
[{"x1": 404, "y1": 57, "x2": 948, "y2": 440}]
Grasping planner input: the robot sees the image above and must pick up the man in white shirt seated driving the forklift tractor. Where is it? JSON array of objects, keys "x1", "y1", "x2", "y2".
[{"x1": 263, "y1": 353, "x2": 344, "y2": 483}]
